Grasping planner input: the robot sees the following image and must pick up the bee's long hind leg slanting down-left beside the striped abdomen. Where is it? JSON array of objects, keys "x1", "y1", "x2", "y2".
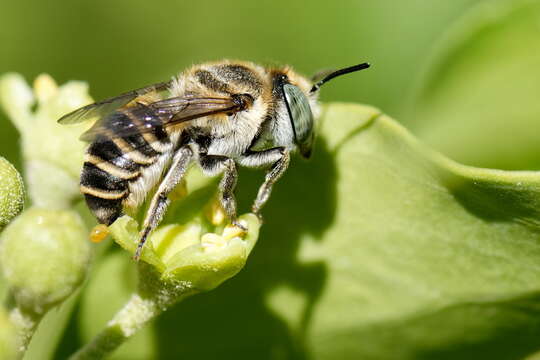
[{"x1": 134, "y1": 146, "x2": 193, "y2": 260}]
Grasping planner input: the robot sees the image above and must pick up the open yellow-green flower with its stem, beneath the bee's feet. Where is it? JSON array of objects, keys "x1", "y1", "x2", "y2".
[{"x1": 71, "y1": 214, "x2": 260, "y2": 360}]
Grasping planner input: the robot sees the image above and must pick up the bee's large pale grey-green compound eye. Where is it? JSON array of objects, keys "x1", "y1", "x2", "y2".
[{"x1": 283, "y1": 84, "x2": 314, "y2": 158}]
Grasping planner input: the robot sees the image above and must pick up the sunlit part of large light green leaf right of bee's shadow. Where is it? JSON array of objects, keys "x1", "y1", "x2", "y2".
[{"x1": 286, "y1": 105, "x2": 540, "y2": 359}]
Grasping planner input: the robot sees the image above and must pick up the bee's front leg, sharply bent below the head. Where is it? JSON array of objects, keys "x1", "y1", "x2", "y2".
[{"x1": 239, "y1": 147, "x2": 291, "y2": 218}]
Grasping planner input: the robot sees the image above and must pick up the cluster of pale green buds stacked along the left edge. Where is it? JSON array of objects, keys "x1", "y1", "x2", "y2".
[{"x1": 0, "y1": 74, "x2": 91, "y2": 359}]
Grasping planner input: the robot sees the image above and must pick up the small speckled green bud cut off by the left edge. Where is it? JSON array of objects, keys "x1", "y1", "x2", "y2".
[{"x1": 0, "y1": 156, "x2": 24, "y2": 230}]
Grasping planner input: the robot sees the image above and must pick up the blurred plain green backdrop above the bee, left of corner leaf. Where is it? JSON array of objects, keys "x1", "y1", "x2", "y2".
[{"x1": 0, "y1": 0, "x2": 490, "y2": 169}]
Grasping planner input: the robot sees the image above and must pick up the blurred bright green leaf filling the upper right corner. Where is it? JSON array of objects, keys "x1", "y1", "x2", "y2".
[{"x1": 407, "y1": 0, "x2": 540, "y2": 169}]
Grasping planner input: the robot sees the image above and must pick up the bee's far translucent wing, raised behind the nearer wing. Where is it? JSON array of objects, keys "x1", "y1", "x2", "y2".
[{"x1": 58, "y1": 81, "x2": 171, "y2": 124}]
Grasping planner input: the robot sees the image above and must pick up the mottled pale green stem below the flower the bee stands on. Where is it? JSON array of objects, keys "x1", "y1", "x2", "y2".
[{"x1": 70, "y1": 262, "x2": 198, "y2": 360}]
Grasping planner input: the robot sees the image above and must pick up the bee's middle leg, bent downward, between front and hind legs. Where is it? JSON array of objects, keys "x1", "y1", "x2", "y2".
[{"x1": 199, "y1": 154, "x2": 246, "y2": 230}]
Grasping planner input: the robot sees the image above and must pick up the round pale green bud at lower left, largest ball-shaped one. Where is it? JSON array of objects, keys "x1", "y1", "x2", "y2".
[{"x1": 0, "y1": 207, "x2": 90, "y2": 314}]
